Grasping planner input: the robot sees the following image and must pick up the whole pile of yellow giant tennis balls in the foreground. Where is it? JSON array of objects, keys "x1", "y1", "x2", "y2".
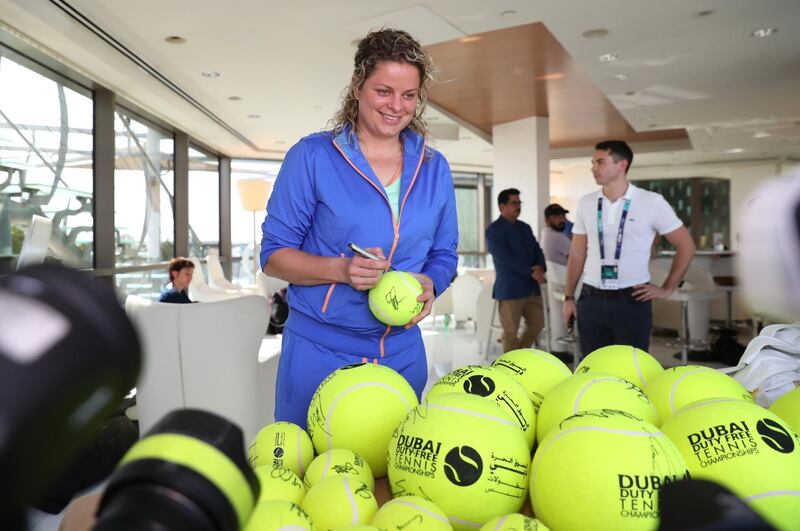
[{"x1": 239, "y1": 345, "x2": 800, "y2": 531}]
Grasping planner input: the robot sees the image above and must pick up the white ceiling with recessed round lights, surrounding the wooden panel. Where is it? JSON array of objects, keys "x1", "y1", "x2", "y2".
[{"x1": 0, "y1": 0, "x2": 800, "y2": 170}]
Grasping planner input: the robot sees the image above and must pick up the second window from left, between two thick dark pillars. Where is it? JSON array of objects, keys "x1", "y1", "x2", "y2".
[{"x1": 114, "y1": 108, "x2": 175, "y2": 267}]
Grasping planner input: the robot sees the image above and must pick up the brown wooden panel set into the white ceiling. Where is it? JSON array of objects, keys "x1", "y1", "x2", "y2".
[{"x1": 427, "y1": 23, "x2": 688, "y2": 149}]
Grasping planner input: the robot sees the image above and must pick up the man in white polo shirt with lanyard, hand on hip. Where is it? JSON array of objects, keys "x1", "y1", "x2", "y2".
[{"x1": 563, "y1": 140, "x2": 695, "y2": 355}]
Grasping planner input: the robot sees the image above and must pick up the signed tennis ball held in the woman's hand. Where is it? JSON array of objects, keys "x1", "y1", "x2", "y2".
[{"x1": 368, "y1": 271, "x2": 423, "y2": 326}]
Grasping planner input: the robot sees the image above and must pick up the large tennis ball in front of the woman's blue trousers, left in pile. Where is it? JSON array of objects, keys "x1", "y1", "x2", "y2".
[{"x1": 308, "y1": 363, "x2": 419, "y2": 478}]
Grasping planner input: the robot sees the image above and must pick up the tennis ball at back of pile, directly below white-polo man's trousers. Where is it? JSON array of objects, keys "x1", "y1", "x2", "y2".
[{"x1": 575, "y1": 345, "x2": 664, "y2": 388}]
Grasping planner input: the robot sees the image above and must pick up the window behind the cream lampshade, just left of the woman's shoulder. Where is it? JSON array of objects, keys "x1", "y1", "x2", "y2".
[{"x1": 231, "y1": 159, "x2": 281, "y2": 284}]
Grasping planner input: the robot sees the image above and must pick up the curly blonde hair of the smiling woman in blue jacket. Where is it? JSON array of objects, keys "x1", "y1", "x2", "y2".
[{"x1": 331, "y1": 29, "x2": 435, "y2": 137}]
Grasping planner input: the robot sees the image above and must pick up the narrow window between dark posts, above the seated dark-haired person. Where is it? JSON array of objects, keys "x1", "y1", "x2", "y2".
[{"x1": 189, "y1": 147, "x2": 219, "y2": 258}]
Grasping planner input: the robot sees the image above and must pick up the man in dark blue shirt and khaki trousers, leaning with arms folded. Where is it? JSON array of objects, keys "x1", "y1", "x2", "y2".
[{"x1": 486, "y1": 188, "x2": 545, "y2": 352}]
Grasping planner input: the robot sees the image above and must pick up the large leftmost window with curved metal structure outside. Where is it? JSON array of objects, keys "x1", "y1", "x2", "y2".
[{"x1": 0, "y1": 46, "x2": 94, "y2": 273}]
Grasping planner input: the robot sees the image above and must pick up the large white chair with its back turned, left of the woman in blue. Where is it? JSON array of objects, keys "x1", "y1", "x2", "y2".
[{"x1": 125, "y1": 295, "x2": 277, "y2": 441}]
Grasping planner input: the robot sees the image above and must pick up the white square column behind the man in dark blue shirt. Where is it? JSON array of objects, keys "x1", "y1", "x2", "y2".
[{"x1": 492, "y1": 116, "x2": 550, "y2": 239}]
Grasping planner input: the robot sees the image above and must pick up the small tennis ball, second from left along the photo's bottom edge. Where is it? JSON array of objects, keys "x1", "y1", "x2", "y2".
[{"x1": 301, "y1": 476, "x2": 378, "y2": 529}]
